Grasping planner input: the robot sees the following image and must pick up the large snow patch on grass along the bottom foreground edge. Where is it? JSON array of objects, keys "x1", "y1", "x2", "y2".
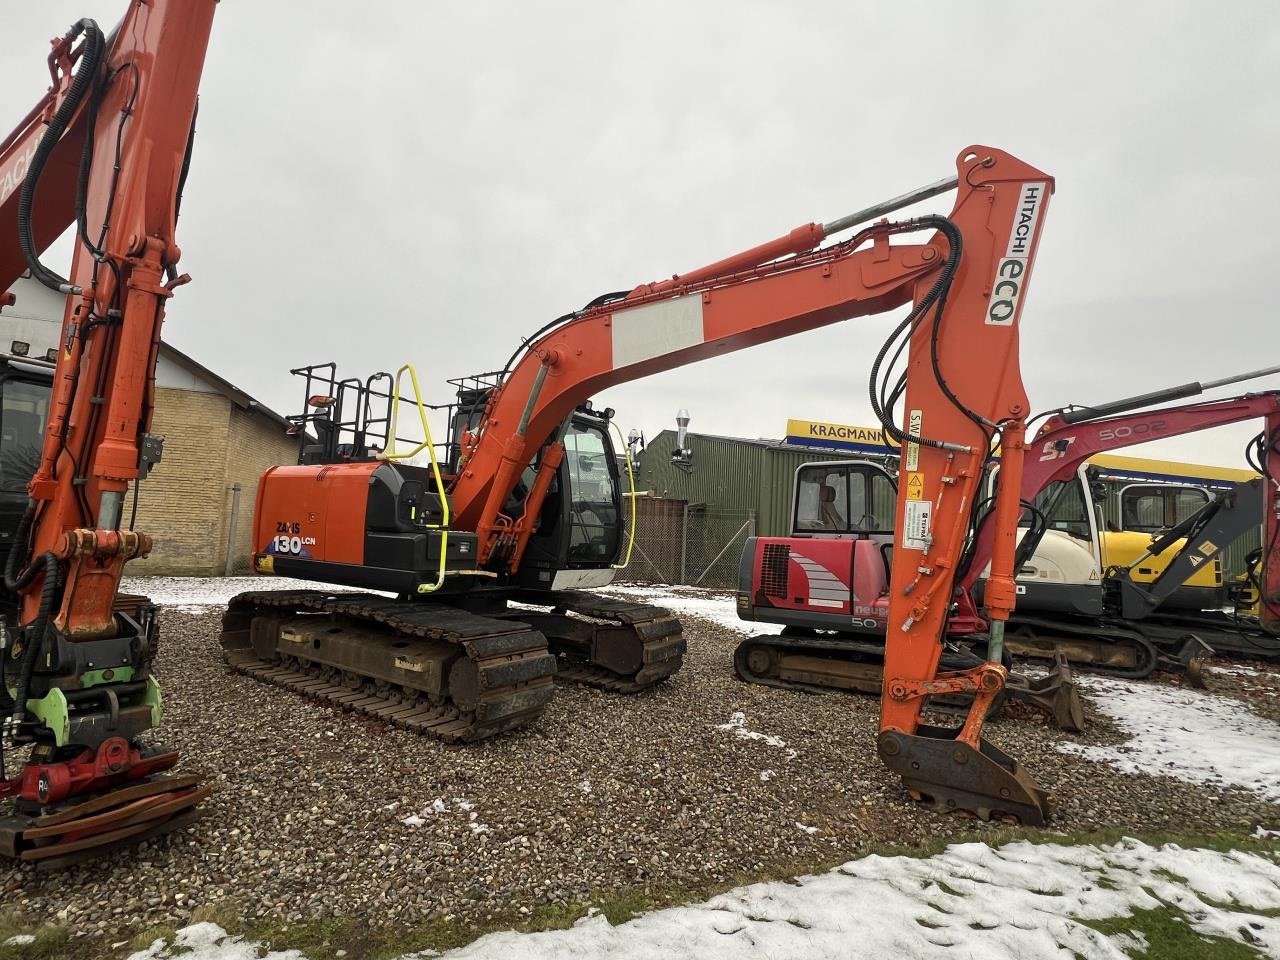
[{"x1": 129, "y1": 840, "x2": 1280, "y2": 960}]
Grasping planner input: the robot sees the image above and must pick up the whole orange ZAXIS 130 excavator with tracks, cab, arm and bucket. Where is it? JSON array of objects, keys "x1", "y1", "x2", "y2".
[{"x1": 223, "y1": 146, "x2": 1053, "y2": 823}]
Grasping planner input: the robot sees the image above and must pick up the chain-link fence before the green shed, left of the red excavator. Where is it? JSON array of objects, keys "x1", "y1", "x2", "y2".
[{"x1": 620, "y1": 497, "x2": 755, "y2": 589}]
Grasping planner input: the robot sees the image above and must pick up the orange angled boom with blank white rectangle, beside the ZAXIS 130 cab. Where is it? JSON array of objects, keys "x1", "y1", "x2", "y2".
[{"x1": 449, "y1": 147, "x2": 1049, "y2": 586}]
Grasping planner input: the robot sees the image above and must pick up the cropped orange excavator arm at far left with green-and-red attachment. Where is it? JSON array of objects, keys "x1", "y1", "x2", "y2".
[{"x1": 0, "y1": 0, "x2": 215, "y2": 867}]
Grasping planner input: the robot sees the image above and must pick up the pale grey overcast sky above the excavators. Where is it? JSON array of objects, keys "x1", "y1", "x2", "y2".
[{"x1": 0, "y1": 0, "x2": 1280, "y2": 465}]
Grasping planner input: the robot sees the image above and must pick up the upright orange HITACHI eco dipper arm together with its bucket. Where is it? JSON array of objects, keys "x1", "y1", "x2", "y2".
[{"x1": 872, "y1": 147, "x2": 1053, "y2": 823}]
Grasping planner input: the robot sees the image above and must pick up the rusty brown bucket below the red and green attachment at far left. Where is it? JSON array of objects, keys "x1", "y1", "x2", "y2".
[{"x1": 0, "y1": 776, "x2": 212, "y2": 870}]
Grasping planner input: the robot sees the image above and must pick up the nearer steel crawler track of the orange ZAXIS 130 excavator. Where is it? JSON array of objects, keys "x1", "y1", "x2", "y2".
[{"x1": 221, "y1": 590, "x2": 556, "y2": 744}]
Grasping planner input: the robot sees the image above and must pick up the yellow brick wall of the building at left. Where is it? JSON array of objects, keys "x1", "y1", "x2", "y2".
[{"x1": 125, "y1": 387, "x2": 298, "y2": 576}]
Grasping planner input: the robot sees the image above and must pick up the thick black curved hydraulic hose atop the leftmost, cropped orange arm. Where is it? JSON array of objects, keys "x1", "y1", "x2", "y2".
[{"x1": 18, "y1": 18, "x2": 106, "y2": 294}]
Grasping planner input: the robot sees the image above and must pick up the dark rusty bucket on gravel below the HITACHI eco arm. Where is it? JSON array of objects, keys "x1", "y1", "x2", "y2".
[{"x1": 877, "y1": 724, "x2": 1053, "y2": 827}]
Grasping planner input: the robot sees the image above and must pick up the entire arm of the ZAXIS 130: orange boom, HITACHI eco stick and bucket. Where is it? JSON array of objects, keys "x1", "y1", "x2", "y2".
[{"x1": 451, "y1": 146, "x2": 1053, "y2": 822}]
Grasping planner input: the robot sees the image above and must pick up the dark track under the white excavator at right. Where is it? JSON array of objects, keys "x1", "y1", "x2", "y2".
[{"x1": 1005, "y1": 612, "x2": 1160, "y2": 680}]
